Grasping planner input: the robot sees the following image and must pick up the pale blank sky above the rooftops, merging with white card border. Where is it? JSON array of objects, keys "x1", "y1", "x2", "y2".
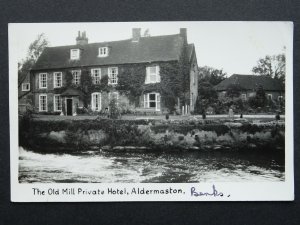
[{"x1": 9, "y1": 22, "x2": 292, "y2": 76}]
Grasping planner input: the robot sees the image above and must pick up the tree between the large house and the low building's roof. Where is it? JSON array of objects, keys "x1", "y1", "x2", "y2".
[{"x1": 199, "y1": 66, "x2": 227, "y2": 85}]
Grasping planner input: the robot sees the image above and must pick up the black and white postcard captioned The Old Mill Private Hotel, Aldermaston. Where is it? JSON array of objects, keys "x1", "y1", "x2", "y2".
[{"x1": 9, "y1": 21, "x2": 294, "y2": 201}]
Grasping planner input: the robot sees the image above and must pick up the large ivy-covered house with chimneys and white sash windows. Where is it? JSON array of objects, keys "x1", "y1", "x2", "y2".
[{"x1": 31, "y1": 28, "x2": 198, "y2": 115}]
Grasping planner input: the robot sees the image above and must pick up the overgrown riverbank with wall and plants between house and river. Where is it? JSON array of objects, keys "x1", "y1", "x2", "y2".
[{"x1": 19, "y1": 117, "x2": 285, "y2": 152}]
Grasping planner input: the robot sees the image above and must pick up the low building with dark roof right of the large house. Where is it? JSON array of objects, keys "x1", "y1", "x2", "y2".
[{"x1": 214, "y1": 74, "x2": 285, "y2": 101}]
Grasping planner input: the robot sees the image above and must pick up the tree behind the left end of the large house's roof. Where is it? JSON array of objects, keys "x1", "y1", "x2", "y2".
[{"x1": 18, "y1": 34, "x2": 49, "y2": 99}]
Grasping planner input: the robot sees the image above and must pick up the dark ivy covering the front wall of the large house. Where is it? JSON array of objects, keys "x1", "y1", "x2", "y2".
[{"x1": 60, "y1": 42, "x2": 190, "y2": 112}]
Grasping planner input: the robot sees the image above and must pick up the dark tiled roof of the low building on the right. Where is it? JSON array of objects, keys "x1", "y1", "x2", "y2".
[{"x1": 214, "y1": 74, "x2": 284, "y2": 91}]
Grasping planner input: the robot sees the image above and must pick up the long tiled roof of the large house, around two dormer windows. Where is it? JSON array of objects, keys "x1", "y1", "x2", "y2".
[{"x1": 33, "y1": 34, "x2": 183, "y2": 70}]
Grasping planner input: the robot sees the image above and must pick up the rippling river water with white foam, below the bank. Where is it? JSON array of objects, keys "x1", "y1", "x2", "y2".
[{"x1": 19, "y1": 148, "x2": 284, "y2": 183}]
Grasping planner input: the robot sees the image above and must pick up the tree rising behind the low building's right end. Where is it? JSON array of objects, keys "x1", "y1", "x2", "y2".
[{"x1": 252, "y1": 53, "x2": 286, "y2": 84}]
